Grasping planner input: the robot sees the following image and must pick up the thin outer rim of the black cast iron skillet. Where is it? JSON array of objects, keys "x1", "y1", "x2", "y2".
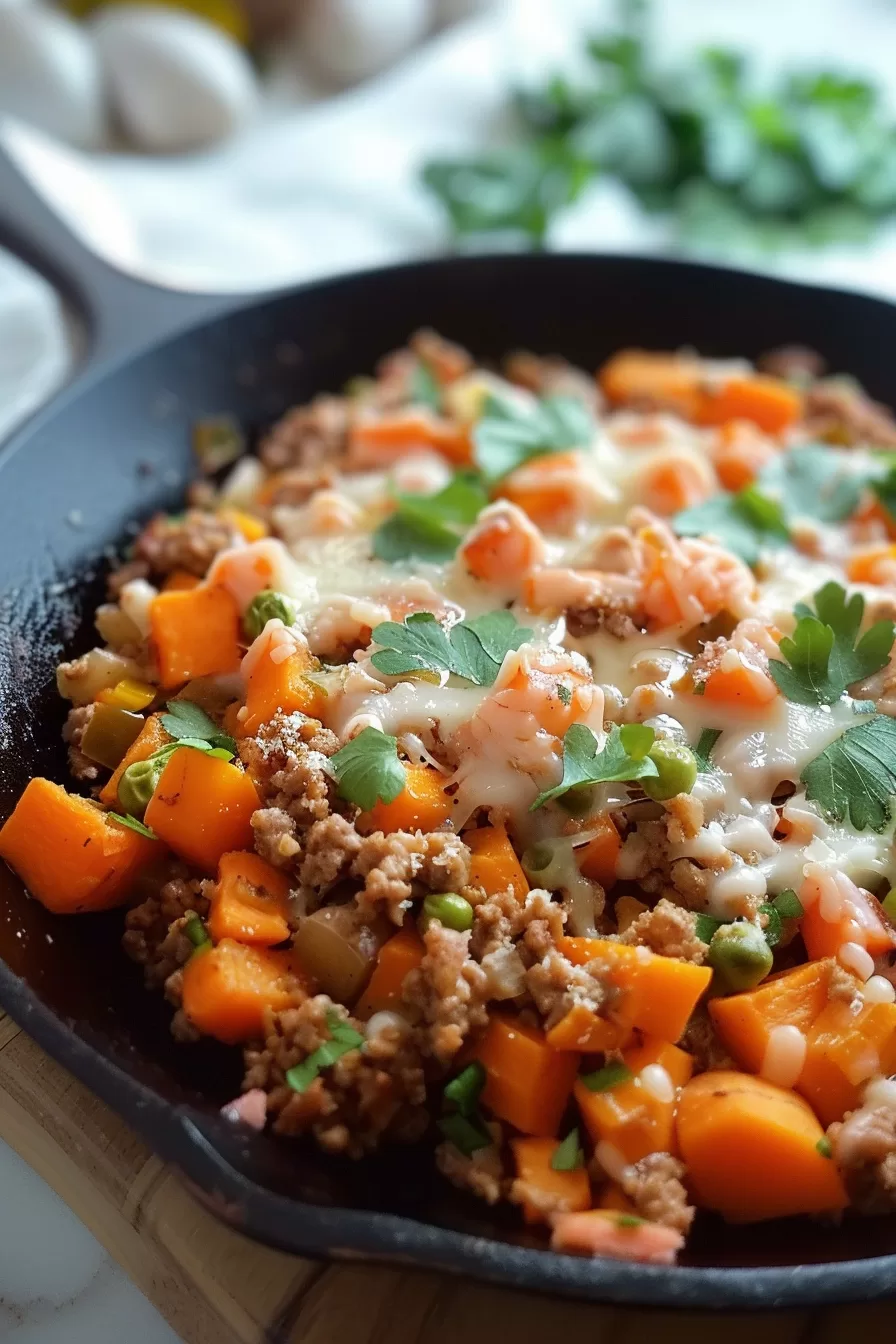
[{"x1": 0, "y1": 253, "x2": 896, "y2": 1310}]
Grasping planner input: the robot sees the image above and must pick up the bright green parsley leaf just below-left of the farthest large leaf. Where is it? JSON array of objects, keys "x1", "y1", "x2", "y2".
[{"x1": 373, "y1": 472, "x2": 489, "y2": 564}]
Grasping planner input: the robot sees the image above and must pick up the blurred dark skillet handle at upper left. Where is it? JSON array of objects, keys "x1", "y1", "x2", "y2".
[{"x1": 0, "y1": 121, "x2": 238, "y2": 367}]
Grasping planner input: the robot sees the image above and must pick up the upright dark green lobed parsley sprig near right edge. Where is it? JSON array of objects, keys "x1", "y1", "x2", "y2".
[{"x1": 768, "y1": 581, "x2": 896, "y2": 704}]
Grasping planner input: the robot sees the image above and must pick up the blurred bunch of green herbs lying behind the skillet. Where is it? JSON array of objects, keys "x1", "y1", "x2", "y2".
[{"x1": 423, "y1": 0, "x2": 896, "y2": 250}]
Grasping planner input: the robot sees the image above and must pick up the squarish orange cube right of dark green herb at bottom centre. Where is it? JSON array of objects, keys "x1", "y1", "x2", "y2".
[{"x1": 476, "y1": 1013, "x2": 579, "y2": 1138}]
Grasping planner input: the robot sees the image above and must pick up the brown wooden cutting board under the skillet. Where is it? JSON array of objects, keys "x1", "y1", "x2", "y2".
[{"x1": 0, "y1": 1013, "x2": 896, "y2": 1344}]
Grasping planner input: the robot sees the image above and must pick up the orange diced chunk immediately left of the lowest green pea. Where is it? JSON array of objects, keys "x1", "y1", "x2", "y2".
[{"x1": 557, "y1": 937, "x2": 712, "y2": 1042}]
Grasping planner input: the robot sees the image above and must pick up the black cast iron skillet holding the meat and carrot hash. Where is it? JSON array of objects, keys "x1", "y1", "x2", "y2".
[{"x1": 0, "y1": 139, "x2": 896, "y2": 1308}]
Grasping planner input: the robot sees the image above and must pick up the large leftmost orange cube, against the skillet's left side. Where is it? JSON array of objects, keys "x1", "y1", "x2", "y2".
[{"x1": 0, "y1": 778, "x2": 160, "y2": 915}]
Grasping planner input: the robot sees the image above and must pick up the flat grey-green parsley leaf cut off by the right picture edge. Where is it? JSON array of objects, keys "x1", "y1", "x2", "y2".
[{"x1": 799, "y1": 714, "x2": 896, "y2": 832}]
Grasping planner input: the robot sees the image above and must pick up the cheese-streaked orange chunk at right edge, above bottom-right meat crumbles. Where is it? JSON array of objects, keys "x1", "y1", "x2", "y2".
[{"x1": 797, "y1": 1000, "x2": 896, "y2": 1126}]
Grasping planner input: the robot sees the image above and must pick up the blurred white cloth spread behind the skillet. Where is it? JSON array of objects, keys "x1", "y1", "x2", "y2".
[{"x1": 0, "y1": 0, "x2": 896, "y2": 434}]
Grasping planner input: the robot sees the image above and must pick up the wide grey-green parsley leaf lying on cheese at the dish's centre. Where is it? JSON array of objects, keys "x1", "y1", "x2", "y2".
[{"x1": 371, "y1": 612, "x2": 532, "y2": 685}]
